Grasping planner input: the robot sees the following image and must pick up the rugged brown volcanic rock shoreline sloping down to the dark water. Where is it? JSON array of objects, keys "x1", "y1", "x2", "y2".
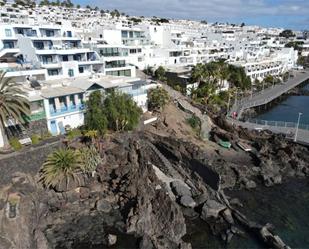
[{"x1": 0, "y1": 111, "x2": 309, "y2": 249}]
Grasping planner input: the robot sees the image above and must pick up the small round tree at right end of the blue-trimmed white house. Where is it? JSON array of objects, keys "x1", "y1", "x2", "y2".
[{"x1": 148, "y1": 87, "x2": 170, "y2": 110}]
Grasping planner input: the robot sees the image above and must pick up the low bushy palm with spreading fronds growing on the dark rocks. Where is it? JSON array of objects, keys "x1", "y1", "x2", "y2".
[{"x1": 40, "y1": 149, "x2": 83, "y2": 188}]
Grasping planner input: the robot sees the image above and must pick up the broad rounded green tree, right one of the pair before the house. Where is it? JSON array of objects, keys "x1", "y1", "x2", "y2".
[{"x1": 104, "y1": 91, "x2": 142, "y2": 131}]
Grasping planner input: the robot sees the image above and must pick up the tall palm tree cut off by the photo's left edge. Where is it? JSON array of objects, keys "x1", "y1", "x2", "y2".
[{"x1": 0, "y1": 73, "x2": 30, "y2": 146}]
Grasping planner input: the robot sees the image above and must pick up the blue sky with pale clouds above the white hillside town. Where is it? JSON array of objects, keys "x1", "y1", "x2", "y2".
[{"x1": 73, "y1": 0, "x2": 309, "y2": 30}]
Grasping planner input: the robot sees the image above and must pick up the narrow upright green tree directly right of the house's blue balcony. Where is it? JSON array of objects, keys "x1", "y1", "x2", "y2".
[{"x1": 84, "y1": 91, "x2": 107, "y2": 135}]
